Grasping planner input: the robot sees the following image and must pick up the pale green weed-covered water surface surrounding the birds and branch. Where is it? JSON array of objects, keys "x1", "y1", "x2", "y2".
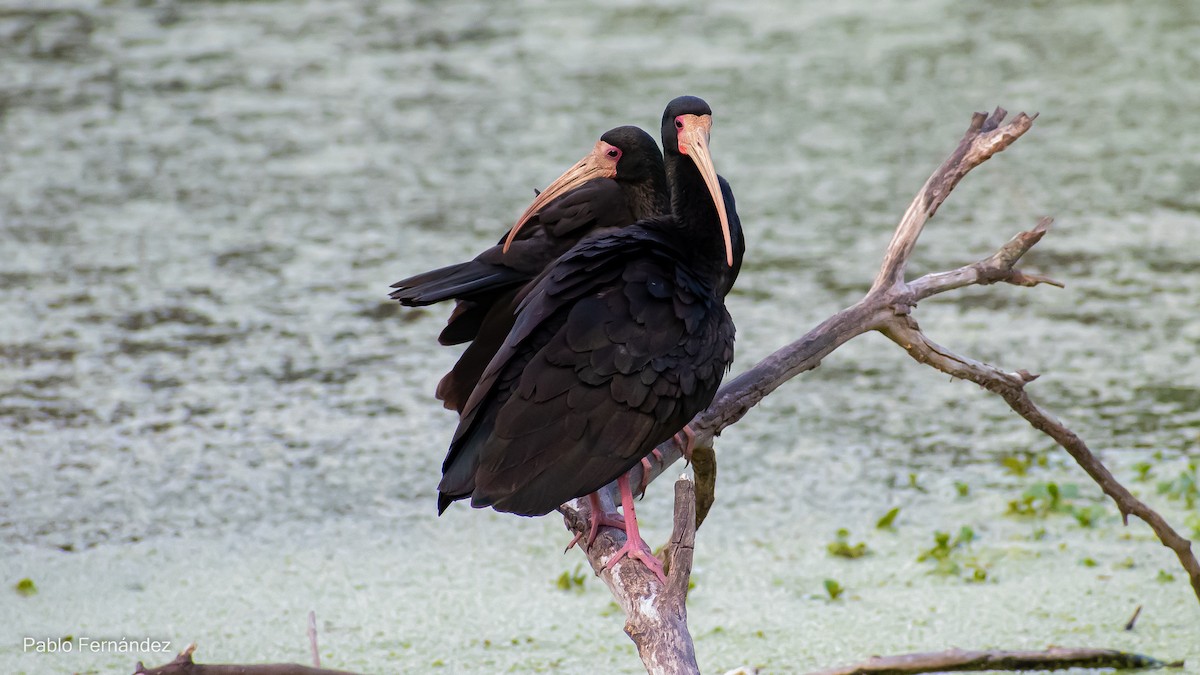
[{"x1": 0, "y1": 0, "x2": 1200, "y2": 673}]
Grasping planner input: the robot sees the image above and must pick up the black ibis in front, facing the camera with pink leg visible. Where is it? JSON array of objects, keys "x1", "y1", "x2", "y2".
[{"x1": 438, "y1": 96, "x2": 742, "y2": 577}]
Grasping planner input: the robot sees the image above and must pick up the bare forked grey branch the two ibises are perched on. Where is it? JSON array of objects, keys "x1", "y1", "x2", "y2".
[{"x1": 560, "y1": 108, "x2": 1200, "y2": 673}]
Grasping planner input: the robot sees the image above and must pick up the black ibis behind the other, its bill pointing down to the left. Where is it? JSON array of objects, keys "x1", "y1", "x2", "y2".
[{"x1": 390, "y1": 126, "x2": 670, "y2": 411}]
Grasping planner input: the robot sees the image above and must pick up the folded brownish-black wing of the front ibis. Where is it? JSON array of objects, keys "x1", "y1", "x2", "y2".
[{"x1": 439, "y1": 226, "x2": 733, "y2": 515}]
